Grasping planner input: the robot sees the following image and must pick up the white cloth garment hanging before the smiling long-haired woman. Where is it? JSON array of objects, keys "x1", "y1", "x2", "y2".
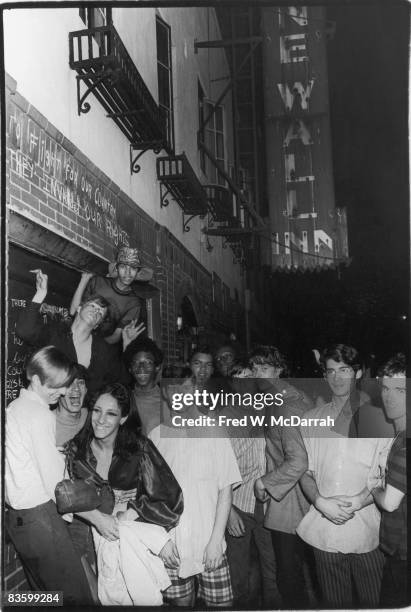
[{"x1": 93, "y1": 521, "x2": 171, "y2": 606}]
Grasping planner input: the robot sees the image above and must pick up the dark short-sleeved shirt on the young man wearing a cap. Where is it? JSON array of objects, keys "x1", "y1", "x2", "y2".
[{"x1": 83, "y1": 276, "x2": 143, "y2": 336}]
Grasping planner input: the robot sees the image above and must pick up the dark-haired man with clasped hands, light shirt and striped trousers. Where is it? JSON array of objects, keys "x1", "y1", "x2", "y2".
[{"x1": 297, "y1": 344, "x2": 391, "y2": 608}]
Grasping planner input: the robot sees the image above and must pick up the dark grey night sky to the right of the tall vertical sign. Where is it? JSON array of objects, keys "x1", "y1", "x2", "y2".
[{"x1": 328, "y1": 3, "x2": 409, "y2": 274}]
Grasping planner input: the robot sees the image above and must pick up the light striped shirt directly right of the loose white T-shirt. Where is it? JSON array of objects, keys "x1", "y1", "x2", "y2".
[{"x1": 231, "y1": 438, "x2": 266, "y2": 514}]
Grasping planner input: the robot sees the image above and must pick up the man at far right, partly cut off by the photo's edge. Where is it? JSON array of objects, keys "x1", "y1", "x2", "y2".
[{"x1": 372, "y1": 353, "x2": 409, "y2": 608}]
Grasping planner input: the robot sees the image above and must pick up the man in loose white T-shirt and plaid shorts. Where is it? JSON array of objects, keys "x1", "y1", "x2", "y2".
[{"x1": 149, "y1": 347, "x2": 241, "y2": 607}]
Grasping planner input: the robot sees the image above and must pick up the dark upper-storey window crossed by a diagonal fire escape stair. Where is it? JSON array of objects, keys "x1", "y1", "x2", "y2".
[{"x1": 198, "y1": 83, "x2": 225, "y2": 185}]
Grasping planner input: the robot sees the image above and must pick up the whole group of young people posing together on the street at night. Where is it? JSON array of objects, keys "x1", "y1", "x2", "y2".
[{"x1": 5, "y1": 248, "x2": 407, "y2": 609}]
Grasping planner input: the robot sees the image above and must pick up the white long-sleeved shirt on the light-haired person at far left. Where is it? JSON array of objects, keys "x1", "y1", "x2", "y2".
[{"x1": 5, "y1": 389, "x2": 65, "y2": 510}]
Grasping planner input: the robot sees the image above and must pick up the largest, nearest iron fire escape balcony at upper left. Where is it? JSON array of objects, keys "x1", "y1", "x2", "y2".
[{"x1": 69, "y1": 24, "x2": 168, "y2": 172}]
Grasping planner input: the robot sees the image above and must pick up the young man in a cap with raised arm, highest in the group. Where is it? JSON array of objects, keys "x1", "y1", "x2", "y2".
[{"x1": 70, "y1": 247, "x2": 153, "y2": 344}]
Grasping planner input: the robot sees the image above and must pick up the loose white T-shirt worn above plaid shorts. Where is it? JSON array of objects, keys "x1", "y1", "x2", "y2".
[{"x1": 149, "y1": 425, "x2": 242, "y2": 578}]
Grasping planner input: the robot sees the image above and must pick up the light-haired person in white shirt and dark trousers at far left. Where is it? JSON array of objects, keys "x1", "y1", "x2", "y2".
[{"x1": 5, "y1": 346, "x2": 92, "y2": 605}]
